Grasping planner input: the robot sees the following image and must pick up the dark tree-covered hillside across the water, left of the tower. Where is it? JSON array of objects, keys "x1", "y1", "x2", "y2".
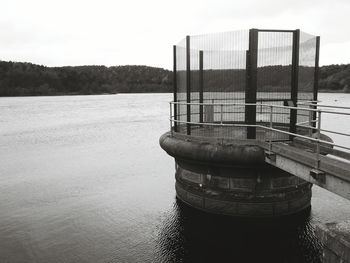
[{"x1": 0, "y1": 61, "x2": 172, "y2": 96}]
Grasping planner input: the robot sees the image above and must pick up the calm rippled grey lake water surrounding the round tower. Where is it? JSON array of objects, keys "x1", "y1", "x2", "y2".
[{"x1": 0, "y1": 94, "x2": 350, "y2": 262}]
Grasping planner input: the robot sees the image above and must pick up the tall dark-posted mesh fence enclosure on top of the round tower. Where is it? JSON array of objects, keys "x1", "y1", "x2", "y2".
[{"x1": 174, "y1": 29, "x2": 319, "y2": 139}]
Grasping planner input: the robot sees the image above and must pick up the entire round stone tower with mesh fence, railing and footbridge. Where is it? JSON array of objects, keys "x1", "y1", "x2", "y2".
[{"x1": 160, "y1": 29, "x2": 350, "y2": 262}]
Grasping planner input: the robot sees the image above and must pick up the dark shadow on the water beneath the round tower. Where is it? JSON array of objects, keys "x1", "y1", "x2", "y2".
[{"x1": 157, "y1": 200, "x2": 321, "y2": 263}]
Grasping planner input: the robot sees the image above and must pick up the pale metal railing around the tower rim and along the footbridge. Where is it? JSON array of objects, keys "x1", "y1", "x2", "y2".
[{"x1": 169, "y1": 101, "x2": 350, "y2": 169}]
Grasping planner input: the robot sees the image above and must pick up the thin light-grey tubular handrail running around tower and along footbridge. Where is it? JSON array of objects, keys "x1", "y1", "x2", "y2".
[{"x1": 169, "y1": 101, "x2": 350, "y2": 169}]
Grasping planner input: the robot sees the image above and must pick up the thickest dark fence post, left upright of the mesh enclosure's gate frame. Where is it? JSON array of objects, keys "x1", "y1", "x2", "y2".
[{"x1": 245, "y1": 29, "x2": 259, "y2": 139}]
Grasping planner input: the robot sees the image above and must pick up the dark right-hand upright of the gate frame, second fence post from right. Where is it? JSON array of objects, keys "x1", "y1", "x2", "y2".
[{"x1": 289, "y1": 29, "x2": 300, "y2": 140}]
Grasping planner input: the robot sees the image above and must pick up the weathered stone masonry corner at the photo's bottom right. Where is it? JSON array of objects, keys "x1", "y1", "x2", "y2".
[{"x1": 316, "y1": 220, "x2": 350, "y2": 263}]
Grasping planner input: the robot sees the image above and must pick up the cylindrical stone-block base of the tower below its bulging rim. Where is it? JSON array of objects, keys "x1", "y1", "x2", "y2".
[{"x1": 176, "y1": 166, "x2": 311, "y2": 217}]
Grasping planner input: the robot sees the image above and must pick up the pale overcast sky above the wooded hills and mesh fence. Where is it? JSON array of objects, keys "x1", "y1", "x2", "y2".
[{"x1": 0, "y1": 0, "x2": 350, "y2": 69}]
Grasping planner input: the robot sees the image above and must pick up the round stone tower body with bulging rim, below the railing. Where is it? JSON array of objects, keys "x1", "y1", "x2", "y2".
[{"x1": 160, "y1": 133, "x2": 312, "y2": 217}]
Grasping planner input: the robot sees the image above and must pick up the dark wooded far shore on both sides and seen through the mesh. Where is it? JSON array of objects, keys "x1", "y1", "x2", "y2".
[{"x1": 0, "y1": 61, "x2": 350, "y2": 97}]
